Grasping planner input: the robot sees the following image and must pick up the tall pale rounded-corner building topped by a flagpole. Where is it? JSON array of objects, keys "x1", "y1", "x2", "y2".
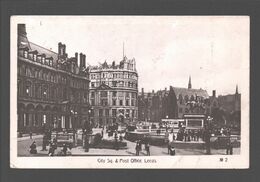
[{"x1": 89, "y1": 56, "x2": 138, "y2": 126}]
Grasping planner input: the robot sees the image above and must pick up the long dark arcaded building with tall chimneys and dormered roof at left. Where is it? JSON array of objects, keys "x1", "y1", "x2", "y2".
[{"x1": 17, "y1": 24, "x2": 89, "y2": 132}]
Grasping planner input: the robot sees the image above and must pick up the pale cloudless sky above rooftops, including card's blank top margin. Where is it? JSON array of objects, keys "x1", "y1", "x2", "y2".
[{"x1": 14, "y1": 16, "x2": 249, "y2": 95}]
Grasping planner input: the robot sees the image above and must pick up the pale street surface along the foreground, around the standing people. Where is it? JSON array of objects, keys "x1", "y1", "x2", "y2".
[{"x1": 18, "y1": 135, "x2": 240, "y2": 157}]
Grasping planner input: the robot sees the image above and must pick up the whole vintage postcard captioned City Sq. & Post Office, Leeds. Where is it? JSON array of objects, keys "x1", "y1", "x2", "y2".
[{"x1": 10, "y1": 16, "x2": 250, "y2": 169}]
